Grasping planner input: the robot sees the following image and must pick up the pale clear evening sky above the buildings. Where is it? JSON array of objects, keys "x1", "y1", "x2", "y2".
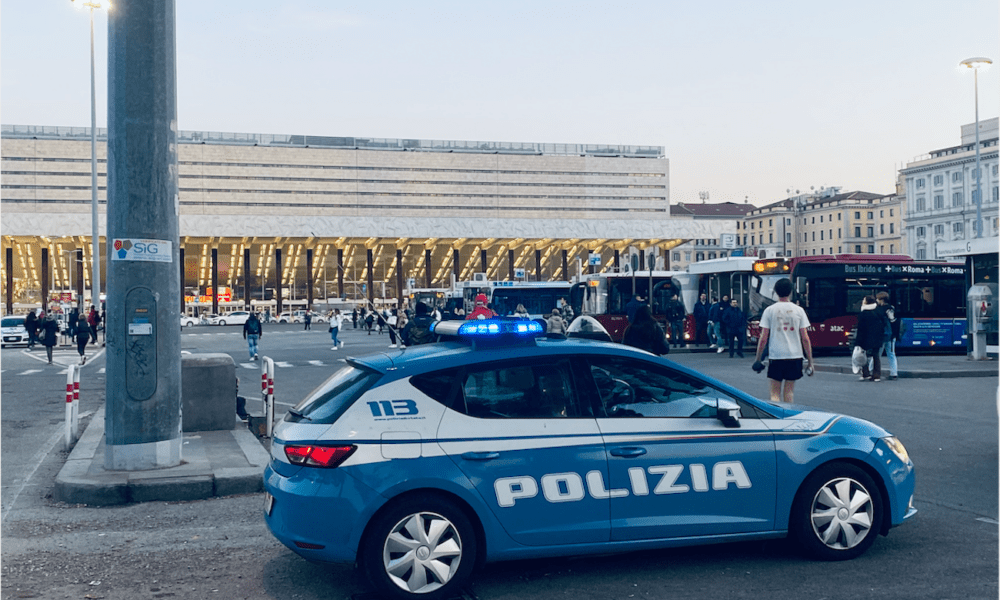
[{"x1": 0, "y1": 0, "x2": 1000, "y2": 205}]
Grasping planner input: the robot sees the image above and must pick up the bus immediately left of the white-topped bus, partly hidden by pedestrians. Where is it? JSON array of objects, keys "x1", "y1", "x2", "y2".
[{"x1": 569, "y1": 271, "x2": 698, "y2": 342}]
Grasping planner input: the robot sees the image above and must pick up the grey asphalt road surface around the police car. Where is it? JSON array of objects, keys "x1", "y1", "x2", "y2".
[{"x1": 0, "y1": 325, "x2": 1000, "y2": 600}]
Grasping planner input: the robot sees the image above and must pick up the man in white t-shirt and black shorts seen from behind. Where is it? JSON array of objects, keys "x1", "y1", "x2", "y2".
[{"x1": 754, "y1": 279, "x2": 813, "y2": 404}]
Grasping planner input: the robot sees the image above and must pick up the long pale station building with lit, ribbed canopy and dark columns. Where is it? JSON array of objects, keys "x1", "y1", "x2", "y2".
[{"x1": 0, "y1": 125, "x2": 738, "y2": 310}]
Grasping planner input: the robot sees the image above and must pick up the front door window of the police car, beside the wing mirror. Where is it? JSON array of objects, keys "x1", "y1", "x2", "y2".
[{"x1": 589, "y1": 357, "x2": 734, "y2": 418}]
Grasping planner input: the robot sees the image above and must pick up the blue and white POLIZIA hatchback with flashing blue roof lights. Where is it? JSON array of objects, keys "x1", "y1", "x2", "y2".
[{"x1": 264, "y1": 319, "x2": 916, "y2": 598}]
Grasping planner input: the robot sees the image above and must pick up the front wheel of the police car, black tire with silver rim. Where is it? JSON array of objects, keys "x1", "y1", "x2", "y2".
[{"x1": 789, "y1": 463, "x2": 884, "y2": 561}]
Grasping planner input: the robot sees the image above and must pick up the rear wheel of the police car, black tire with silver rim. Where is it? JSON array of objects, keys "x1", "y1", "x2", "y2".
[{"x1": 361, "y1": 496, "x2": 477, "y2": 600}]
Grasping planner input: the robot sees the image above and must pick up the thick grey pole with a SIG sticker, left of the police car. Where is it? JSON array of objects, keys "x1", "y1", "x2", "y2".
[{"x1": 106, "y1": 0, "x2": 182, "y2": 471}]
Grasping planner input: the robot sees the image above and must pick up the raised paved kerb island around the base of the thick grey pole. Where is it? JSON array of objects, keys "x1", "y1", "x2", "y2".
[{"x1": 54, "y1": 407, "x2": 269, "y2": 506}]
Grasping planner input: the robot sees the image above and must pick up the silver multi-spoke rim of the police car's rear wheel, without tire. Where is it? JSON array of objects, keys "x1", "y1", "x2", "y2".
[{"x1": 382, "y1": 512, "x2": 462, "y2": 594}]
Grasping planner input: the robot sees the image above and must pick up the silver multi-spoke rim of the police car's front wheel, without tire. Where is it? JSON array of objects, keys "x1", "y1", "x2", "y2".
[{"x1": 809, "y1": 477, "x2": 874, "y2": 550}]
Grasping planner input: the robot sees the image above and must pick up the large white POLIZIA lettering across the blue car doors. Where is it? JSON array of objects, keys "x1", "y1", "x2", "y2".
[{"x1": 493, "y1": 460, "x2": 752, "y2": 508}]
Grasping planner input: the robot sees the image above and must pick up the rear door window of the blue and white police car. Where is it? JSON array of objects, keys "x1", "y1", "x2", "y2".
[{"x1": 453, "y1": 360, "x2": 580, "y2": 419}]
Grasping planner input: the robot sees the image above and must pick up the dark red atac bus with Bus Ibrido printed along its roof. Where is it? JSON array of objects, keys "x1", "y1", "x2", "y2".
[{"x1": 749, "y1": 254, "x2": 967, "y2": 350}]
